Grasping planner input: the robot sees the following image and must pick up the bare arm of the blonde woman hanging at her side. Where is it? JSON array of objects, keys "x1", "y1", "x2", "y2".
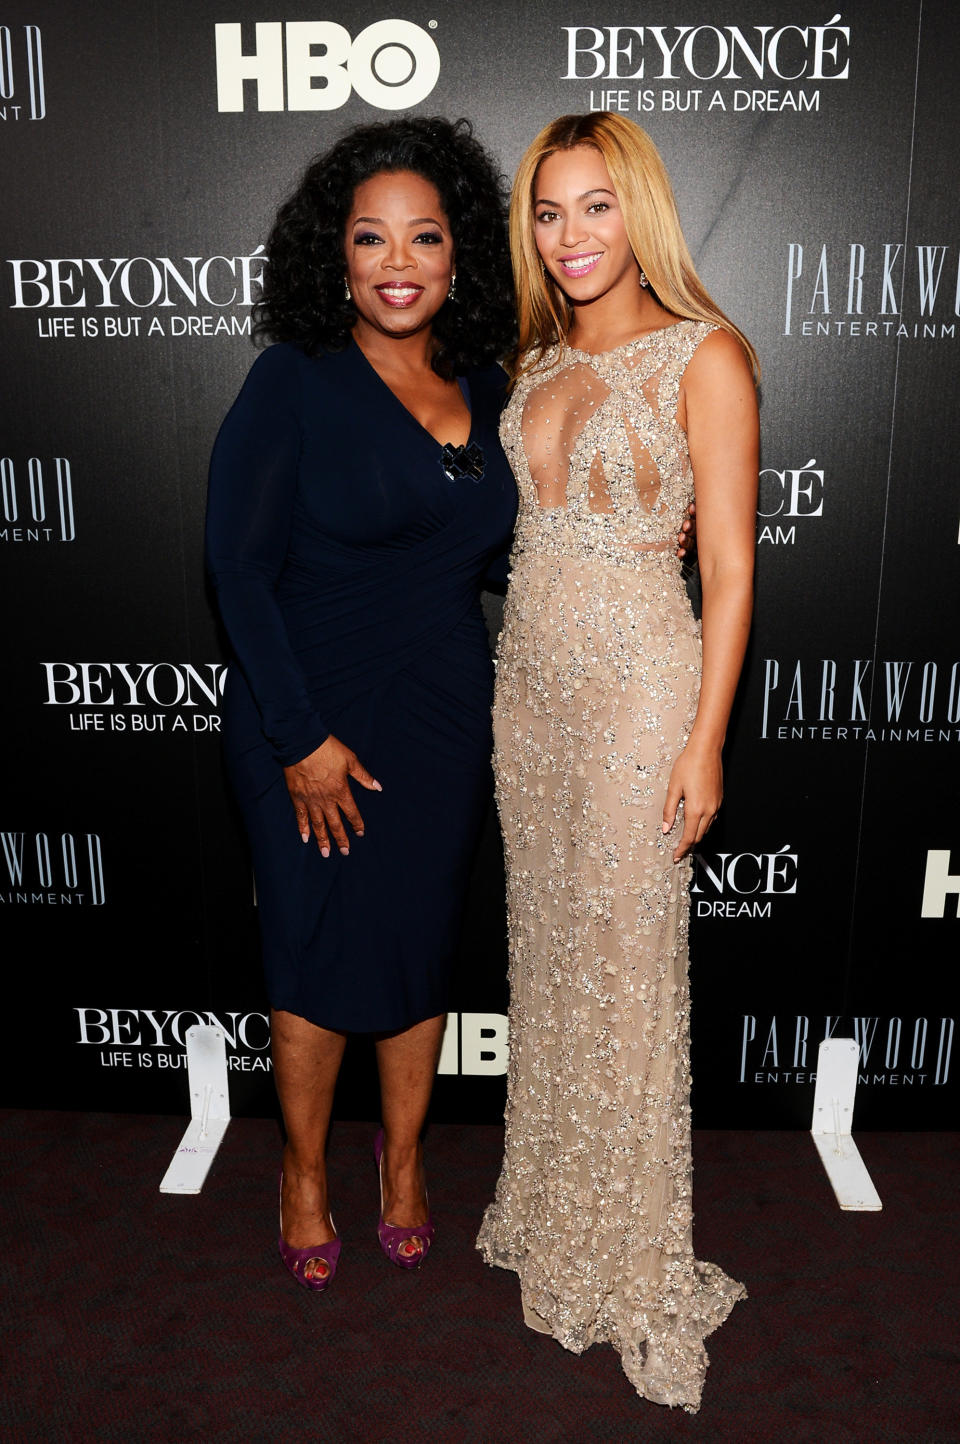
[{"x1": 664, "y1": 331, "x2": 759, "y2": 862}]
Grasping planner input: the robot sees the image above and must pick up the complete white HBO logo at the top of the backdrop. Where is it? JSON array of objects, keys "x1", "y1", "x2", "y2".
[{"x1": 214, "y1": 20, "x2": 440, "y2": 110}]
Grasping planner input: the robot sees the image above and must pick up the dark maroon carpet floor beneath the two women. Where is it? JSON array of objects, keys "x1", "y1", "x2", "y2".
[{"x1": 0, "y1": 1112, "x2": 960, "y2": 1444}]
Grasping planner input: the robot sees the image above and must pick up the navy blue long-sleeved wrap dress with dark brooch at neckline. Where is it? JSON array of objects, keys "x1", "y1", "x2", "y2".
[{"x1": 206, "y1": 342, "x2": 517, "y2": 1032}]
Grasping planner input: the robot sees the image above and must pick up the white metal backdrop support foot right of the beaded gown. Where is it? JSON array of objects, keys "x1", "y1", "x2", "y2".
[{"x1": 810, "y1": 1038, "x2": 883, "y2": 1213}]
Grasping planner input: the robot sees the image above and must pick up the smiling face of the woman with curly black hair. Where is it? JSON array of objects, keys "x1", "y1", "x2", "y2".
[{"x1": 344, "y1": 170, "x2": 453, "y2": 336}]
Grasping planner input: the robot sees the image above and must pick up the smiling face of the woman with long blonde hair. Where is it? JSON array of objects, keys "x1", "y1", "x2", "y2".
[{"x1": 533, "y1": 146, "x2": 640, "y2": 305}]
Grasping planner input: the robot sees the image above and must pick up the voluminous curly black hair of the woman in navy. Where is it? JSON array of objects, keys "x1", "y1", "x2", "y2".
[{"x1": 254, "y1": 116, "x2": 515, "y2": 380}]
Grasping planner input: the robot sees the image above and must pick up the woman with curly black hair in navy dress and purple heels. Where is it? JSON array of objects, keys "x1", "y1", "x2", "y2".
[{"x1": 206, "y1": 117, "x2": 515, "y2": 1289}]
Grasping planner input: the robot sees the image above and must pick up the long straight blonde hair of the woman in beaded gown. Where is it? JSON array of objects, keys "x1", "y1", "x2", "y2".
[{"x1": 507, "y1": 111, "x2": 759, "y2": 380}]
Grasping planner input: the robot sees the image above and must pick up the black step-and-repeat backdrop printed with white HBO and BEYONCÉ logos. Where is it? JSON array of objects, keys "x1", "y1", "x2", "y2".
[{"x1": 0, "y1": 0, "x2": 960, "y2": 1128}]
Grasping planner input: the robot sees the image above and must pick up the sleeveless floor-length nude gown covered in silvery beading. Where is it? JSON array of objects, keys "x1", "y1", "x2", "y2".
[{"x1": 478, "y1": 321, "x2": 745, "y2": 1411}]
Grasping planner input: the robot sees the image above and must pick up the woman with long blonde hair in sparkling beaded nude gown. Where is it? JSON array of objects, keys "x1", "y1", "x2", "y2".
[{"x1": 478, "y1": 114, "x2": 758, "y2": 1411}]
